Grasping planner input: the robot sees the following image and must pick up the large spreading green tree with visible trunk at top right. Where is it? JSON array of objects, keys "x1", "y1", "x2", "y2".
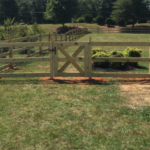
[{"x1": 111, "y1": 0, "x2": 150, "y2": 27}]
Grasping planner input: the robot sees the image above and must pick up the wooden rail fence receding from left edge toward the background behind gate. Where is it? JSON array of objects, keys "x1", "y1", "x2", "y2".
[{"x1": 0, "y1": 28, "x2": 87, "y2": 70}]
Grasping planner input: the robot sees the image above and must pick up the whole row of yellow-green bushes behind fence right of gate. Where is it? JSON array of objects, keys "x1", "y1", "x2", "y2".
[{"x1": 92, "y1": 47, "x2": 142, "y2": 69}]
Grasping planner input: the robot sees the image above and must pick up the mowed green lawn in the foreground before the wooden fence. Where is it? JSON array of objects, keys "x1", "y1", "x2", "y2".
[{"x1": 0, "y1": 35, "x2": 150, "y2": 150}]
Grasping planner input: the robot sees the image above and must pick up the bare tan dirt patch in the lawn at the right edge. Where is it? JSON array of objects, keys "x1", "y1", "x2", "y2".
[{"x1": 119, "y1": 78, "x2": 150, "y2": 109}]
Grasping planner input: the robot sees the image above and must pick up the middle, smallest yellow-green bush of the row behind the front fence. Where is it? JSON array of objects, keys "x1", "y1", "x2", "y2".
[{"x1": 110, "y1": 51, "x2": 124, "y2": 69}]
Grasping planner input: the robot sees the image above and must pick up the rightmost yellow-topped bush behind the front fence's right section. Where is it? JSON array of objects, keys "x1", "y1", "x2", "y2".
[{"x1": 123, "y1": 47, "x2": 142, "y2": 66}]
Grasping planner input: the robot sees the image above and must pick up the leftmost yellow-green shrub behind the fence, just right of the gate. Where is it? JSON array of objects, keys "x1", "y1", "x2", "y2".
[{"x1": 92, "y1": 51, "x2": 110, "y2": 67}]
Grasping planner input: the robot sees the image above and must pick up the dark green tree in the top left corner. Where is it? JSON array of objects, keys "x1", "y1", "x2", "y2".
[{"x1": 0, "y1": 0, "x2": 19, "y2": 24}]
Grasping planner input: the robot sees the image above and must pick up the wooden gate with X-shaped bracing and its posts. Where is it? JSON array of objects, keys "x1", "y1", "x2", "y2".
[{"x1": 50, "y1": 42, "x2": 92, "y2": 79}]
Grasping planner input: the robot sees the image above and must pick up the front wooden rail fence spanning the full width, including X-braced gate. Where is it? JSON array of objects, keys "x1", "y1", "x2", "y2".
[{"x1": 0, "y1": 41, "x2": 150, "y2": 79}]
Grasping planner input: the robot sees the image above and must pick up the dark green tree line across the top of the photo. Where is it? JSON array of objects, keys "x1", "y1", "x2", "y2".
[{"x1": 0, "y1": 0, "x2": 150, "y2": 25}]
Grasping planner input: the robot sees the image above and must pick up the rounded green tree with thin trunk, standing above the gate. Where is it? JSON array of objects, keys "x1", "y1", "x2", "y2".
[{"x1": 45, "y1": 0, "x2": 78, "y2": 27}]
